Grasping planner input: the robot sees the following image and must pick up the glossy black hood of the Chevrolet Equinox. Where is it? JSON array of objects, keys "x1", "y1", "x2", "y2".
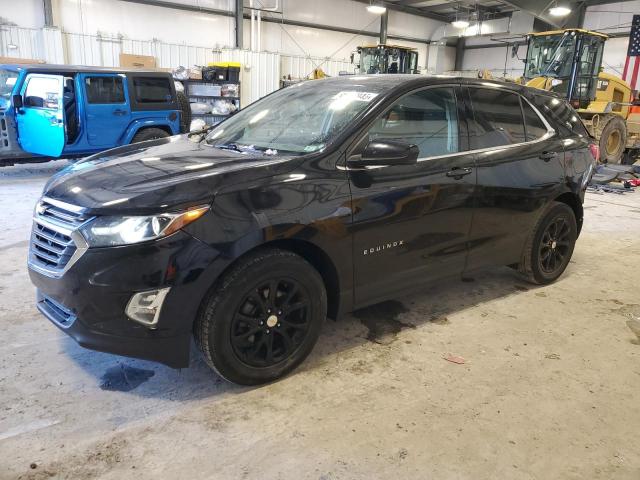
[{"x1": 43, "y1": 135, "x2": 295, "y2": 214}]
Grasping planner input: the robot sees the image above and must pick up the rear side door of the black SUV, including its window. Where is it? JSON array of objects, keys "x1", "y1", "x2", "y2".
[{"x1": 467, "y1": 87, "x2": 565, "y2": 270}]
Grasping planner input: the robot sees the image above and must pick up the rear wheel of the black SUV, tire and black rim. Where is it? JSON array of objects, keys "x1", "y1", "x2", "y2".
[{"x1": 519, "y1": 202, "x2": 578, "y2": 285}]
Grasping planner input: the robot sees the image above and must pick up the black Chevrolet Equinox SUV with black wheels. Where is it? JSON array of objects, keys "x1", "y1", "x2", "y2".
[{"x1": 29, "y1": 75, "x2": 598, "y2": 384}]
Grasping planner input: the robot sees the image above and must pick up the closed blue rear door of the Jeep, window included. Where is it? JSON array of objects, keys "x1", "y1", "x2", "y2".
[{"x1": 80, "y1": 73, "x2": 131, "y2": 148}]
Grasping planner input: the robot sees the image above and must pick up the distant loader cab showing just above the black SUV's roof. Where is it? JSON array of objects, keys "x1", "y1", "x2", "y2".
[{"x1": 358, "y1": 45, "x2": 418, "y2": 73}]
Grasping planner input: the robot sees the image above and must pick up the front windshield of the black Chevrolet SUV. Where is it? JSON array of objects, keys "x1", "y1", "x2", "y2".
[{"x1": 206, "y1": 77, "x2": 380, "y2": 155}]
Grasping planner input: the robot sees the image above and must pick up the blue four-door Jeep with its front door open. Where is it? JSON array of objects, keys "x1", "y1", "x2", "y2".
[{"x1": 0, "y1": 65, "x2": 191, "y2": 166}]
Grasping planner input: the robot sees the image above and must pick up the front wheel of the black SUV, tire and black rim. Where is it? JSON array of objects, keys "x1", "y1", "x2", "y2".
[{"x1": 194, "y1": 249, "x2": 327, "y2": 385}]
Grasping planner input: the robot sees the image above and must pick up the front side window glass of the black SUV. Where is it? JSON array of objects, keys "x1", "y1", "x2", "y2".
[{"x1": 369, "y1": 88, "x2": 459, "y2": 158}]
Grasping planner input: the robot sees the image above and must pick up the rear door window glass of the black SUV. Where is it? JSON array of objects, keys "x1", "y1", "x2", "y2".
[{"x1": 469, "y1": 88, "x2": 525, "y2": 150}]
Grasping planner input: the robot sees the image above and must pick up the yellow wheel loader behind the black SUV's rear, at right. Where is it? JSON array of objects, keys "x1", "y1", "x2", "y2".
[{"x1": 522, "y1": 28, "x2": 640, "y2": 163}]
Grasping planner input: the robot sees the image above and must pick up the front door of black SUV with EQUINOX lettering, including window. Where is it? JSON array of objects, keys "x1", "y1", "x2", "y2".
[{"x1": 348, "y1": 86, "x2": 475, "y2": 305}]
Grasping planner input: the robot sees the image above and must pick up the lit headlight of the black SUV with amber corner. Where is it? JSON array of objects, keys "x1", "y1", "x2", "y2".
[{"x1": 80, "y1": 207, "x2": 209, "y2": 247}]
